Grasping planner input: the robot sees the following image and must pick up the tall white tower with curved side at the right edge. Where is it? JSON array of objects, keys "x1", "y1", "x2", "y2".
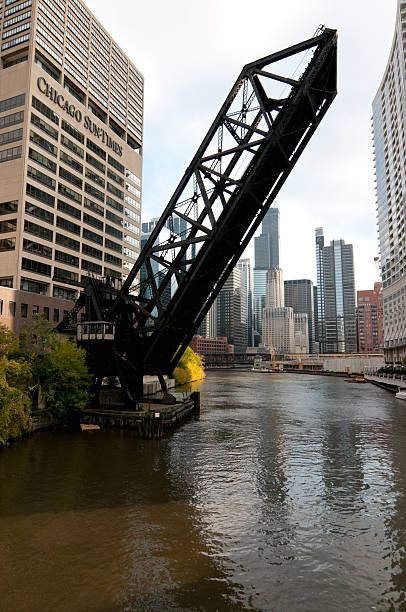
[{"x1": 372, "y1": 0, "x2": 406, "y2": 363}]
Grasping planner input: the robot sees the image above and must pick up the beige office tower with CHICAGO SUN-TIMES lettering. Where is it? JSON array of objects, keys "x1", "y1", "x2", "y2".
[{"x1": 0, "y1": 0, "x2": 144, "y2": 332}]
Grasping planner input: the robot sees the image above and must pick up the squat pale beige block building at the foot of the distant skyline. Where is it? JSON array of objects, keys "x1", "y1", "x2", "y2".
[{"x1": 262, "y1": 307, "x2": 295, "y2": 354}]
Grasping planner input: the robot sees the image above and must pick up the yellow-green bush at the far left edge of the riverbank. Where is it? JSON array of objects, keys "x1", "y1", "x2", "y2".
[{"x1": 0, "y1": 326, "x2": 32, "y2": 446}]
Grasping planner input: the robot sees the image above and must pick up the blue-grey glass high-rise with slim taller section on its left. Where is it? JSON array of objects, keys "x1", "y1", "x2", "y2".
[{"x1": 316, "y1": 228, "x2": 357, "y2": 353}]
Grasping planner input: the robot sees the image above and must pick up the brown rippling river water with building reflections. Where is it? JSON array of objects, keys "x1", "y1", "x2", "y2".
[{"x1": 0, "y1": 371, "x2": 406, "y2": 612}]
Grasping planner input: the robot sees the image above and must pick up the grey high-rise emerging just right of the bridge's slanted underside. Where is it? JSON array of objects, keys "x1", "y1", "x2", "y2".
[{"x1": 216, "y1": 267, "x2": 247, "y2": 353}]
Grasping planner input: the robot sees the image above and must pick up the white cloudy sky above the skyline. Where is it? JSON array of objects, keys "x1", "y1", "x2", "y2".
[{"x1": 86, "y1": 0, "x2": 396, "y2": 289}]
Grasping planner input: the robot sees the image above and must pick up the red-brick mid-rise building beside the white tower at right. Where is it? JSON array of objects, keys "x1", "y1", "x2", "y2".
[{"x1": 357, "y1": 283, "x2": 383, "y2": 353}]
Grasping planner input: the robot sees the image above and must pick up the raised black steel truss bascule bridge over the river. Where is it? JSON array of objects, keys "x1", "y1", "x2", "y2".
[{"x1": 59, "y1": 27, "x2": 337, "y2": 409}]
